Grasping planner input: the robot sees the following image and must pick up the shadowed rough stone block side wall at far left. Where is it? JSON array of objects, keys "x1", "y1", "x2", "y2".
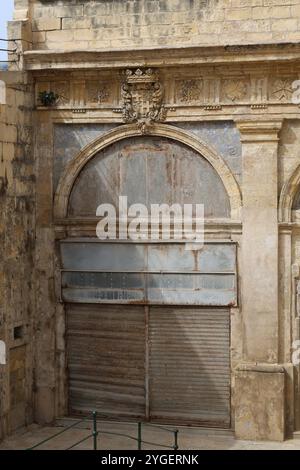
[{"x1": 0, "y1": 72, "x2": 34, "y2": 438}]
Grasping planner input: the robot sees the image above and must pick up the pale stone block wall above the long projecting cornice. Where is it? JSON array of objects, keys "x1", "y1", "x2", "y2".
[{"x1": 15, "y1": 0, "x2": 300, "y2": 49}]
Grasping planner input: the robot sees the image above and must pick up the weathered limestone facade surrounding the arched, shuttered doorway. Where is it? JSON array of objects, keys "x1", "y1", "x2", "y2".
[{"x1": 0, "y1": 0, "x2": 300, "y2": 439}]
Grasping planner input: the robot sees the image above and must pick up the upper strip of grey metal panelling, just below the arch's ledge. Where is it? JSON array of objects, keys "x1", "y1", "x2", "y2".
[{"x1": 60, "y1": 238, "x2": 236, "y2": 273}]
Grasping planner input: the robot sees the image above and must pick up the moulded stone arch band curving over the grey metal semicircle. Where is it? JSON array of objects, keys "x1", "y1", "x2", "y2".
[{"x1": 54, "y1": 124, "x2": 242, "y2": 221}]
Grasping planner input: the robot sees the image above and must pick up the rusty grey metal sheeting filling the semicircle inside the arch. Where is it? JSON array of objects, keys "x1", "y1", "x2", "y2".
[{"x1": 68, "y1": 136, "x2": 230, "y2": 218}]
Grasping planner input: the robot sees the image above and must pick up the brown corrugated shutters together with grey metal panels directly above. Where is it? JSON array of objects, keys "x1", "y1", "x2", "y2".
[{"x1": 61, "y1": 240, "x2": 233, "y2": 427}]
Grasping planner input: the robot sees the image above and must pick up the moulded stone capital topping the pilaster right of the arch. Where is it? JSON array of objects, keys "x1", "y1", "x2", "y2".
[{"x1": 236, "y1": 119, "x2": 283, "y2": 143}]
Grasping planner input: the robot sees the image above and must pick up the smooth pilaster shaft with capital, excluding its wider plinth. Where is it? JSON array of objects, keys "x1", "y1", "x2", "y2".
[{"x1": 238, "y1": 121, "x2": 281, "y2": 363}]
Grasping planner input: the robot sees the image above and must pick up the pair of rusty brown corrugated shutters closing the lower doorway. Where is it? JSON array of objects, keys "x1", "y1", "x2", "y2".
[{"x1": 67, "y1": 304, "x2": 230, "y2": 428}]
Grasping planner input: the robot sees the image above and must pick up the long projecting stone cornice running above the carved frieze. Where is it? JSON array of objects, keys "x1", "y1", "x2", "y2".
[{"x1": 24, "y1": 43, "x2": 300, "y2": 70}]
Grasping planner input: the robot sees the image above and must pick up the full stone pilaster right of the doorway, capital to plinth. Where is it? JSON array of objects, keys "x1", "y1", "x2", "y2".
[{"x1": 234, "y1": 121, "x2": 286, "y2": 440}]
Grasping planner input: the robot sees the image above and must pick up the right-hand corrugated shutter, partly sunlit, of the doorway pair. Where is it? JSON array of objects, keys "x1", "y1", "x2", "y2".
[{"x1": 149, "y1": 307, "x2": 230, "y2": 427}]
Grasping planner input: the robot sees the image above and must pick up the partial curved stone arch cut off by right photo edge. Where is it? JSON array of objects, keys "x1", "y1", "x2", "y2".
[{"x1": 278, "y1": 164, "x2": 300, "y2": 222}]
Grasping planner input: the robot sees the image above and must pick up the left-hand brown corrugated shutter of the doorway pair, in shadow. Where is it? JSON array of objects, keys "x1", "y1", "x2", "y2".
[{"x1": 67, "y1": 304, "x2": 145, "y2": 419}]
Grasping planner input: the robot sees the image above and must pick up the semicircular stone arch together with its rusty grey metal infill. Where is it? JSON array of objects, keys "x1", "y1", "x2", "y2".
[{"x1": 55, "y1": 125, "x2": 241, "y2": 220}]
